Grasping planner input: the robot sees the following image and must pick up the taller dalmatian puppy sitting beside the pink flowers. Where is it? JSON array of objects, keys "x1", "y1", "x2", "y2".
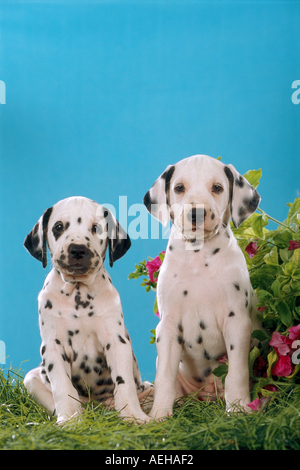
[{"x1": 144, "y1": 155, "x2": 262, "y2": 420}]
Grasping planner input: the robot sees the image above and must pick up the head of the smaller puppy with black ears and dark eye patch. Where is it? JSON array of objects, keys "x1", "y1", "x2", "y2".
[{"x1": 24, "y1": 197, "x2": 131, "y2": 278}]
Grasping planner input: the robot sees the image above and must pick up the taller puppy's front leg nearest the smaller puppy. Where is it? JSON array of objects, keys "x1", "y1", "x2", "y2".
[{"x1": 149, "y1": 315, "x2": 182, "y2": 420}]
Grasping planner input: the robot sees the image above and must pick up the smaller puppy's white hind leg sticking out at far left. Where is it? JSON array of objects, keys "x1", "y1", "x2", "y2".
[{"x1": 24, "y1": 367, "x2": 55, "y2": 415}]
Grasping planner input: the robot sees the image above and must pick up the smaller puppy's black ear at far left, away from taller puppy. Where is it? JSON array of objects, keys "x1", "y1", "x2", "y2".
[{"x1": 24, "y1": 207, "x2": 53, "y2": 268}]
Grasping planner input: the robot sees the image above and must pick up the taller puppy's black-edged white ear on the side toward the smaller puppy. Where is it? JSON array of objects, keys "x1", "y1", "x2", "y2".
[{"x1": 143, "y1": 165, "x2": 175, "y2": 227}]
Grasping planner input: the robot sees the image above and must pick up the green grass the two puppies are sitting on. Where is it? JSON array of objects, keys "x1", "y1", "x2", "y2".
[{"x1": 0, "y1": 369, "x2": 300, "y2": 451}]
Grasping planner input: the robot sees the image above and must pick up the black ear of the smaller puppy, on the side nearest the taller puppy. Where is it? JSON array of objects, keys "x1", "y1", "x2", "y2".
[{"x1": 103, "y1": 207, "x2": 131, "y2": 267}]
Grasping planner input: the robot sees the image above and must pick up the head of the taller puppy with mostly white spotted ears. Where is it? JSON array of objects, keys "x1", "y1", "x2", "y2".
[{"x1": 144, "y1": 155, "x2": 260, "y2": 240}]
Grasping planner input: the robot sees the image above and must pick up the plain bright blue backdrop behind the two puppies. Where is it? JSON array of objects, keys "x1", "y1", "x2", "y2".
[{"x1": 0, "y1": 0, "x2": 300, "y2": 380}]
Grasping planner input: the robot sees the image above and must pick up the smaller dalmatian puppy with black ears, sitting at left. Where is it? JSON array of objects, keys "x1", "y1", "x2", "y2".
[{"x1": 24, "y1": 197, "x2": 153, "y2": 423}]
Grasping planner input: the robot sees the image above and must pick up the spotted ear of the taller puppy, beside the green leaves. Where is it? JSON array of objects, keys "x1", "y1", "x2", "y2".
[{"x1": 224, "y1": 165, "x2": 260, "y2": 228}]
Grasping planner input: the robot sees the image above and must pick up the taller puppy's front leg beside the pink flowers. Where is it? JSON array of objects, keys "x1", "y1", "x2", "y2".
[{"x1": 225, "y1": 315, "x2": 252, "y2": 412}]
